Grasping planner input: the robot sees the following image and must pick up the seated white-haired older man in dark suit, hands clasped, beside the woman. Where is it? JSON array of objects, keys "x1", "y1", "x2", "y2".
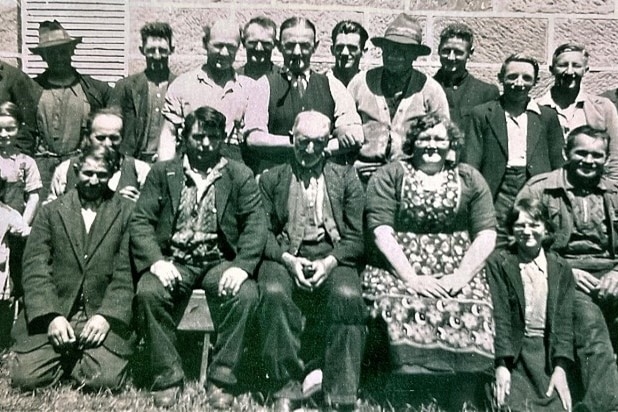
[{"x1": 258, "y1": 111, "x2": 367, "y2": 411}]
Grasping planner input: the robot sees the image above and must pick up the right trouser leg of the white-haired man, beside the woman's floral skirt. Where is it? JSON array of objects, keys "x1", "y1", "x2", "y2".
[{"x1": 316, "y1": 266, "x2": 367, "y2": 404}]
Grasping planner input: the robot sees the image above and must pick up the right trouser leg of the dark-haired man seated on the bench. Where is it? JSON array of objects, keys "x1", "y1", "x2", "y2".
[{"x1": 201, "y1": 262, "x2": 258, "y2": 386}]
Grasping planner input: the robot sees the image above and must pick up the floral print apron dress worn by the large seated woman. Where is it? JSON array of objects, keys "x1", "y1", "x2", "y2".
[{"x1": 362, "y1": 162, "x2": 493, "y2": 372}]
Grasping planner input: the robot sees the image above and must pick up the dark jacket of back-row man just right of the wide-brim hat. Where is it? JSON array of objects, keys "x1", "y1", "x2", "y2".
[{"x1": 434, "y1": 70, "x2": 500, "y2": 131}]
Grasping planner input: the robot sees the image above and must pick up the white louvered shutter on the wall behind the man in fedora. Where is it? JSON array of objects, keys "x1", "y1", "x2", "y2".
[{"x1": 21, "y1": 0, "x2": 128, "y2": 83}]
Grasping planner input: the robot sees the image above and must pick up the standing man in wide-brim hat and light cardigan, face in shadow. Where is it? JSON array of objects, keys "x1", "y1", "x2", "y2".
[{"x1": 348, "y1": 13, "x2": 449, "y2": 178}]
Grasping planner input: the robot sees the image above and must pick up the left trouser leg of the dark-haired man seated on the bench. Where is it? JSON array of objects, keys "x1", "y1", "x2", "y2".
[{"x1": 135, "y1": 265, "x2": 194, "y2": 390}]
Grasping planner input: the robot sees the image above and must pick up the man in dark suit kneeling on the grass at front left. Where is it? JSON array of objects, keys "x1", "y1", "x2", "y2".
[{"x1": 10, "y1": 147, "x2": 134, "y2": 390}]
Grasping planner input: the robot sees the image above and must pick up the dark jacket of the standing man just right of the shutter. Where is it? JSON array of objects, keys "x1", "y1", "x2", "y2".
[{"x1": 109, "y1": 72, "x2": 176, "y2": 158}]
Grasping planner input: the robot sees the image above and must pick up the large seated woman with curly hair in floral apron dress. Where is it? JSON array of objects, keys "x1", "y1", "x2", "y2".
[{"x1": 362, "y1": 114, "x2": 496, "y2": 372}]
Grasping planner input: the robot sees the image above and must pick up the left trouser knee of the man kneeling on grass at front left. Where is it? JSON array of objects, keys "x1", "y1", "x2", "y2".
[{"x1": 9, "y1": 343, "x2": 63, "y2": 390}]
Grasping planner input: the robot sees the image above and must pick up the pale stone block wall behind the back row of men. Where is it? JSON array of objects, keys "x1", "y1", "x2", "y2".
[{"x1": 6, "y1": 0, "x2": 618, "y2": 94}]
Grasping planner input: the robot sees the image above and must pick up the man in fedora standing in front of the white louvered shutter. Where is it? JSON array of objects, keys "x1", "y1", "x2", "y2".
[{"x1": 30, "y1": 20, "x2": 111, "y2": 199}]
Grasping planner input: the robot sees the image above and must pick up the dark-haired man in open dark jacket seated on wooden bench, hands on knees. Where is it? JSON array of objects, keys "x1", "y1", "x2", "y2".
[{"x1": 131, "y1": 107, "x2": 266, "y2": 410}]
